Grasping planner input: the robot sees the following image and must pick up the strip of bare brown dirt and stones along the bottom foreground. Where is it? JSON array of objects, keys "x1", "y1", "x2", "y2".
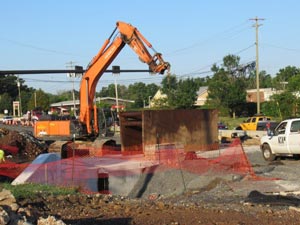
[{"x1": 1, "y1": 190, "x2": 300, "y2": 225}]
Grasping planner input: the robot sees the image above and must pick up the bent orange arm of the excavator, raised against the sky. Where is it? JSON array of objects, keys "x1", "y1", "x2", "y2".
[{"x1": 79, "y1": 21, "x2": 170, "y2": 135}]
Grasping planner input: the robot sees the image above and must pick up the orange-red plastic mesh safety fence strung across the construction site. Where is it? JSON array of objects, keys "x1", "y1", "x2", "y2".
[{"x1": 0, "y1": 139, "x2": 272, "y2": 192}]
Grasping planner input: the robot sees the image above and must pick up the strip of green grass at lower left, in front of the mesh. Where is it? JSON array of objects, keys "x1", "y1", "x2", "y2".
[{"x1": 1, "y1": 183, "x2": 78, "y2": 199}]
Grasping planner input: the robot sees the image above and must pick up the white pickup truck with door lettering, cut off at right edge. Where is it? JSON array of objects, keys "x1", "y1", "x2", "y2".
[{"x1": 260, "y1": 118, "x2": 300, "y2": 161}]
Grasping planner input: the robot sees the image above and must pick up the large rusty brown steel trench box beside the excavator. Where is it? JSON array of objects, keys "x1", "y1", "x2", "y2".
[{"x1": 119, "y1": 109, "x2": 219, "y2": 152}]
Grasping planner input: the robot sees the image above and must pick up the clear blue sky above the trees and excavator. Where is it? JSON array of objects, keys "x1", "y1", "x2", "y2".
[{"x1": 0, "y1": 0, "x2": 300, "y2": 93}]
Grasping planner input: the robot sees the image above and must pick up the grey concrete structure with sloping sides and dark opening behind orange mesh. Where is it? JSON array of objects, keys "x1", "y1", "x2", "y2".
[{"x1": 12, "y1": 153, "x2": 158, "y2": 195}]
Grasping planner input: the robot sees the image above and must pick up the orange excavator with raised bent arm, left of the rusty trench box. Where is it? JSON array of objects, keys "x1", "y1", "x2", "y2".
[{"x1": 34, "y1": 21, "x2": 170, "y2": 140}]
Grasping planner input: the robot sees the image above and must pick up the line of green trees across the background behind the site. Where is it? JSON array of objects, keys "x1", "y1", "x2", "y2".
[{"x1": 0, "y1": 55, "x2": 300, "y2": 119}]
